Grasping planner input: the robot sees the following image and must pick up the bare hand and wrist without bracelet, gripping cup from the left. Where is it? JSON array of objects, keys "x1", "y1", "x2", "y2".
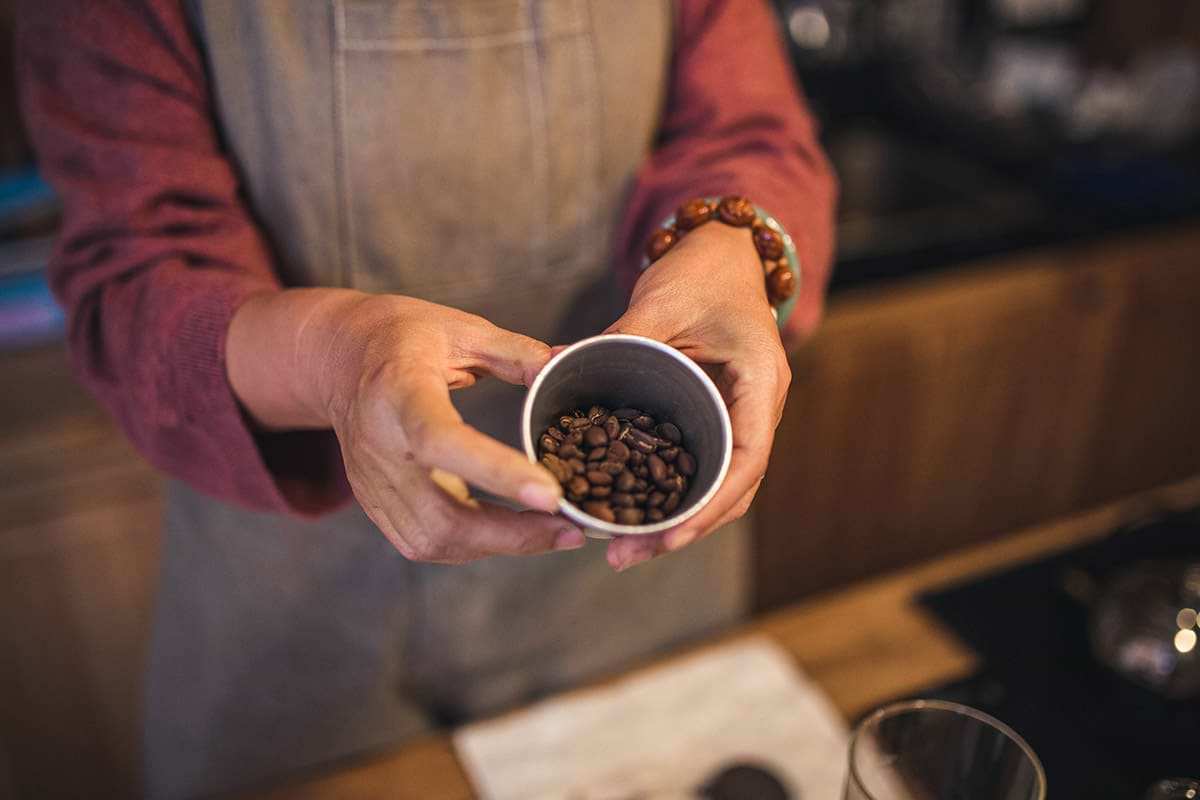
[{"x1": 227, "y1": 289, "x2": 584, "y2": 564}]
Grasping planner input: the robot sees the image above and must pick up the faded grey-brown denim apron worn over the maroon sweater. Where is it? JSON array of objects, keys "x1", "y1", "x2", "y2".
[{"x1": 144, "y1": 0, "x2": 746, "y2": 796}]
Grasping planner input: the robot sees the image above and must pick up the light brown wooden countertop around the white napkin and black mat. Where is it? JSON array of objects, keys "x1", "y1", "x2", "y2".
[{"x1": 244, "y1": 477, "x2": 1200, "y2": 800}]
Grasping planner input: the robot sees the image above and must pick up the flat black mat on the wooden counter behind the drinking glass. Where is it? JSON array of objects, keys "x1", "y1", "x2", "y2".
[{"x1": 919, "y1": 511, "x2": 1200, "y2": 800}]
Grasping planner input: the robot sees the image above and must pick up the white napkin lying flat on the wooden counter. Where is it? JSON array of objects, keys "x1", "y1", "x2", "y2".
[{"x1": 454, "y1": 637, "x2": 847, "y2": 800}]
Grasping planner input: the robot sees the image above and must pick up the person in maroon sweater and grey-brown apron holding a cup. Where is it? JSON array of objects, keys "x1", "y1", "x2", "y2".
[{"x1": 18, "y1": 0, "x2": 835, "y2": 796}]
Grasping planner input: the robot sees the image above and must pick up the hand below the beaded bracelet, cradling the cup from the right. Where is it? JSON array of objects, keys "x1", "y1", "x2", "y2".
[{"x1": 605, "y1": 223, "x2": 792, "y2": 571}]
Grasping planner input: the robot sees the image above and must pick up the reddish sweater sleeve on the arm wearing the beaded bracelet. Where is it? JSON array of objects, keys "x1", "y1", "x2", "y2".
[{"x1": 616, "y1": 0, "x2": 836, "y2": 335}]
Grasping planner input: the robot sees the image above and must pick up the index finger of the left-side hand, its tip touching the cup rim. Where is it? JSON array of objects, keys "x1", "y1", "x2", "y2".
[{"x1": 400, "y1": 371, "x2": 563, "y2": 512}]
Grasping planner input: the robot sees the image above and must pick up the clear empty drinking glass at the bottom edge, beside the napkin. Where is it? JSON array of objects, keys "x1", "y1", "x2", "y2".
[{"x1": 844, "y1": 700, "x2": 1046, "y2": 800}]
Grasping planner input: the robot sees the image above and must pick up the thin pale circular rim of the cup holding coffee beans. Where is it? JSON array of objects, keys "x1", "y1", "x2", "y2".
[{"x1": 521, "y1": 333, "x2": 733, "y2": 536}]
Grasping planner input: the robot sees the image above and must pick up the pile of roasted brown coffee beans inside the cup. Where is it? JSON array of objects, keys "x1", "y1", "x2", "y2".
[{"x1": 538, "y1": 405, "x2": 696, "y2": 525}]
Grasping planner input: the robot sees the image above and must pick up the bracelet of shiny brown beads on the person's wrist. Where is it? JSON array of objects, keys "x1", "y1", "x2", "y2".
[{"x1": 642, "y1": 194, "x2": 800, "y2": 326}]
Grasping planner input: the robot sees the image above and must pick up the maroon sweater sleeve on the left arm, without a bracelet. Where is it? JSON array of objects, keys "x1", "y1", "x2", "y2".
[{"x1": 18, "y1": 0, "x2": 349, "y2": 513}]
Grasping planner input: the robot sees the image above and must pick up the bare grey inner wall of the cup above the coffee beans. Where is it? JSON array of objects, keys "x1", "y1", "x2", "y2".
[{"x1": 526, "y1": 337, "x2": 727, "y2": 528}]
